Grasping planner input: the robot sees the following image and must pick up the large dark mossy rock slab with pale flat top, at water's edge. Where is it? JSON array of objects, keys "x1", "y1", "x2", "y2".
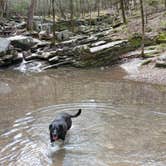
[{"x1": 74, "y1": 40, "x2": 133, "y2": 67}]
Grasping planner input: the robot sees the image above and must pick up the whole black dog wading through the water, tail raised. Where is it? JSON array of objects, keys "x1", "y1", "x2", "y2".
[{"x1": 49, "y1": 109, "x2": 81, "y2": 143}]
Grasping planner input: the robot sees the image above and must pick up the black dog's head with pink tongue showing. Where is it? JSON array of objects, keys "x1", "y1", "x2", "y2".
[{"x1": 49, "y1": 124, "x2": 63, "y2": 142}]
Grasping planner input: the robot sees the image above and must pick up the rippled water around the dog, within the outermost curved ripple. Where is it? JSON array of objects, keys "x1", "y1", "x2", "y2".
[{"x1": 0, "y1": 100, "x2": 166, "y2": 166}]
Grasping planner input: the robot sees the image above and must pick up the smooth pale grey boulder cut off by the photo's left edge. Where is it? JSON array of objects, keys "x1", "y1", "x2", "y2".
[{"x1": 0, "y1": 37, "x2": 10, "y2": 57}]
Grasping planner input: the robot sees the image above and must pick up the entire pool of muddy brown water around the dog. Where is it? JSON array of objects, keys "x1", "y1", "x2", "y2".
[{"x1": 0, "y1": 68, "x2": 166, "y2": 166}]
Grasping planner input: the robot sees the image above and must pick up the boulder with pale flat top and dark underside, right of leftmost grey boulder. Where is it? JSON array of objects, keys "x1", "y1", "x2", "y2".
[{"x1": 8, "y1": 35, "x2": 38, "y2": 50}]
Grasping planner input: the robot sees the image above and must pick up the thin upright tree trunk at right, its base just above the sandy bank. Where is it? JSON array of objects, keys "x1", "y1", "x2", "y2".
[{"x1": 140, "y1": 0, "x2": 145, "y2": 57}]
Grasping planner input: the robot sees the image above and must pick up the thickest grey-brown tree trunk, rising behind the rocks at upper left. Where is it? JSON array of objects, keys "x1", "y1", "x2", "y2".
[{"x1": 27, "y1": 0, "x2": 37, "y2": 30}]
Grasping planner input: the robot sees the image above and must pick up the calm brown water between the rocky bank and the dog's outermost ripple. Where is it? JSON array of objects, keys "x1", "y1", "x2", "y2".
[{"x1": 0, "y1": 67, "x2": 166, "y2": 110}]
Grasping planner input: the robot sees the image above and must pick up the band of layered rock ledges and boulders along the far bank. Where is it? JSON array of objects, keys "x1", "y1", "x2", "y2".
[{"x1": 0, "y1": 15, "x2": 166, "y2": 80}]
